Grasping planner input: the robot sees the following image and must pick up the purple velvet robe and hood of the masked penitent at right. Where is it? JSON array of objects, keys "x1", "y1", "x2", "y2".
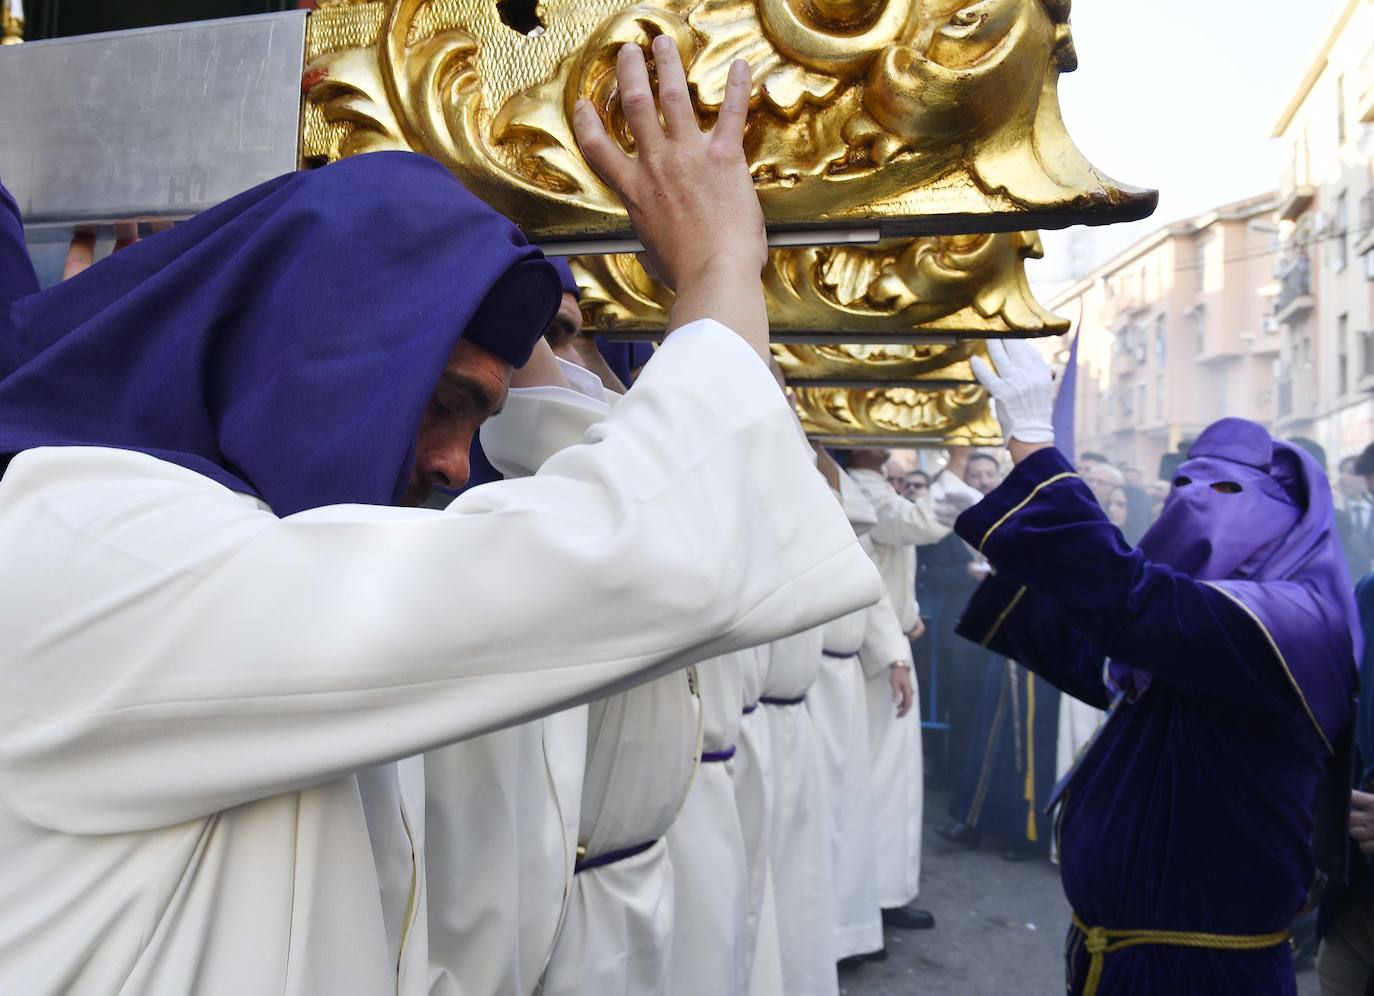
[{"x1": 956, "y1": 419, "x2": 1358, "y2": 996}]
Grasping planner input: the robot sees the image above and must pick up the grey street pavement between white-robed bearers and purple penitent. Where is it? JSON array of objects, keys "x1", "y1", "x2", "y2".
[{"x1": 840, "y1": 793, "x2": 1319, "y2": 996}]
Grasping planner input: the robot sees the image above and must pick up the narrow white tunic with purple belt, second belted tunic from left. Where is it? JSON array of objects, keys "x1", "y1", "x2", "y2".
[{"x1": 668, "y1": 650, "x2": 754, "y2": 996}]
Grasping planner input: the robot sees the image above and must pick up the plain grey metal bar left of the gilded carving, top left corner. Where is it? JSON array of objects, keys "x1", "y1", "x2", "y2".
[{"x1": 0, "y1": 11, "x2": 305, "y2": 242}]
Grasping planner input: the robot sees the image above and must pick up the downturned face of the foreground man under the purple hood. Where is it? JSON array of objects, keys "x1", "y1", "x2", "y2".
[{"x1": 403, "y1": 339, "x2": 511, "y2": 507}]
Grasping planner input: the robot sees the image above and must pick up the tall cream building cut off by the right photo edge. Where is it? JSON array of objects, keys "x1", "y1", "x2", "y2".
[{"x1": 1274, "y1": 0, "x2": 1374, "y2": 470}]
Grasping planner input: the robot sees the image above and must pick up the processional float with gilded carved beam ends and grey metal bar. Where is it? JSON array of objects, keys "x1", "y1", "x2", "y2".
[{"x1": 0, "y1": 0, "x2": 1157, "y2": 445}]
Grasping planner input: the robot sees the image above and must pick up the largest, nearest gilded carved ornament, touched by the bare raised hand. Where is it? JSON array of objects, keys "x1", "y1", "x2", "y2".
[{"x1": 302, "y1": 0, "x2": 1157, "y2": 242}]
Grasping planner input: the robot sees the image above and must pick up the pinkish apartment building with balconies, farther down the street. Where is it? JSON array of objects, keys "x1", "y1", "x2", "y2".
[{"x1": 1050, "y1": 194, "x2": 1282, "y2": 481}]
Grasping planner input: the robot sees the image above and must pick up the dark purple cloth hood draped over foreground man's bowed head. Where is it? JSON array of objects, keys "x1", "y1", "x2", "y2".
[{"x1": 0, "y1": 152, "x2": 559, "y2": 515}]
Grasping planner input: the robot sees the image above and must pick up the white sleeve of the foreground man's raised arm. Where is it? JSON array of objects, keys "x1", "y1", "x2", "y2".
[{"x1": 0, "y1": 321, "x2": 881, "y2": 833}]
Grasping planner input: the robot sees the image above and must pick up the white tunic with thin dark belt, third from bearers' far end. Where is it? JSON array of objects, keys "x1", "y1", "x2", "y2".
[{"x1": 760, "y1": 628, "x2": 838, "y2": 996}]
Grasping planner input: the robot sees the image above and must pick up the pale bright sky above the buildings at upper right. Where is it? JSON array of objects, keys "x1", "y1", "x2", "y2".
[{"x1": 1028, "y1": 0, "x2": 1344, "y2": 291}]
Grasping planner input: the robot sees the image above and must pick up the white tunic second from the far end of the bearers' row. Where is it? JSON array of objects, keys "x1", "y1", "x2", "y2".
[{"x1": 807, "y1": 474, "x2": 882, "y2": 960}]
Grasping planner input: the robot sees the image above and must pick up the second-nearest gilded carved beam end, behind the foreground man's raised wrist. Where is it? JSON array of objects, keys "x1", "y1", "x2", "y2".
[{"x1": 572, "y1": 232, "x2": 1069, "y2": 342}]
